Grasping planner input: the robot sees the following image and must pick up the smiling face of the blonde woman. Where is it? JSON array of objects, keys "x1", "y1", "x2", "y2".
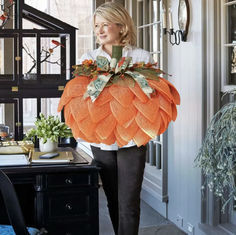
[{"x1": 94, "y1": 16, "x2": 122, "y2": 47}]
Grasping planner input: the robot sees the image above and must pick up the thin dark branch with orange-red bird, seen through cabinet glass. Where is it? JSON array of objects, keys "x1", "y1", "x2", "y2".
[{"x1": 22, "y1": 40, "x2": 64, "y2": 73}]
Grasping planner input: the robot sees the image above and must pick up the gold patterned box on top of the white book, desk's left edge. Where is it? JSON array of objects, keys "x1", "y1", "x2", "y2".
[{"x1": 0, "y1": 141, "x2": 34, "y2": 154}]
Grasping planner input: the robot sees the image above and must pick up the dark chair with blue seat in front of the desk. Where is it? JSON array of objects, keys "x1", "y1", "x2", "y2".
[{"x1": 0, "y1": 170, "x2": 47, "y2": 235}]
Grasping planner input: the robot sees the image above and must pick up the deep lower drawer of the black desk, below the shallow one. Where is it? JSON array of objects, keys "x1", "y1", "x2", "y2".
[{"x1": 36, "y1": 188, "x2": 98, "y2": 221}]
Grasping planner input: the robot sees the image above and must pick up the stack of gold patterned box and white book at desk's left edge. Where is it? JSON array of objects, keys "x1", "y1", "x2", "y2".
[{"x1": 0, "y1": 141, "x2": 34, "y2": 166}]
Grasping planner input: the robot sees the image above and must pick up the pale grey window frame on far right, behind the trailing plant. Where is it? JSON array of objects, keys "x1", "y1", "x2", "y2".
[{"x1": 199, "y1": 0, "x2": 236, "y2": 234}]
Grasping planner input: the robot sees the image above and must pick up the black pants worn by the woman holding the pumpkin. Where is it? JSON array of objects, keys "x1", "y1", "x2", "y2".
[{"x1": 91, "y1": 146, "x2": 146, "y2": 235}]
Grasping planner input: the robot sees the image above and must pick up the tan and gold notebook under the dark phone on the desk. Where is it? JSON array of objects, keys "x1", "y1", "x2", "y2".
[{"x1": 31, "y1": 152, "x2": 74, "y2": 163}]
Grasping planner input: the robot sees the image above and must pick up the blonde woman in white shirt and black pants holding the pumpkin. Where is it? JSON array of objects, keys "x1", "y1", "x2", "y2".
[{"x1": 80, "y1": 2, "x2": 153, "y2": 235}]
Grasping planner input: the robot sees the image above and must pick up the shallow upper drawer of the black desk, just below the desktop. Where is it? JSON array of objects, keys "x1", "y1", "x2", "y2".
[{"x1": 45, "y1": 172, "x2": 92, "y2": 188}]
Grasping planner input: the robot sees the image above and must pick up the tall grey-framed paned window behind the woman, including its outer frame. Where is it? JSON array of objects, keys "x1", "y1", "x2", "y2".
[{"x1": 132, "y1": 0, "x2": 168, "y2": 217}]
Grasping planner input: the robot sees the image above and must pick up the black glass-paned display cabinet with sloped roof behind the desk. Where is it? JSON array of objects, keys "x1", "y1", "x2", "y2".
[{"x1": 0, "y1": 0, "x2": 76, "y2": 140}]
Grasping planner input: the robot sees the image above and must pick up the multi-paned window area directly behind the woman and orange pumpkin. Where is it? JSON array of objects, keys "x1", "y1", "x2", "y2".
[{"x1": 133, "y1": 0, "x2": 168, "y2": 216}]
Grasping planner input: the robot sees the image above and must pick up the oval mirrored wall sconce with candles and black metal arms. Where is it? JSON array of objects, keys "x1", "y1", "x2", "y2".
[{"x1": 162, "y1": 0, "x2": 190, "y2": 46}]
